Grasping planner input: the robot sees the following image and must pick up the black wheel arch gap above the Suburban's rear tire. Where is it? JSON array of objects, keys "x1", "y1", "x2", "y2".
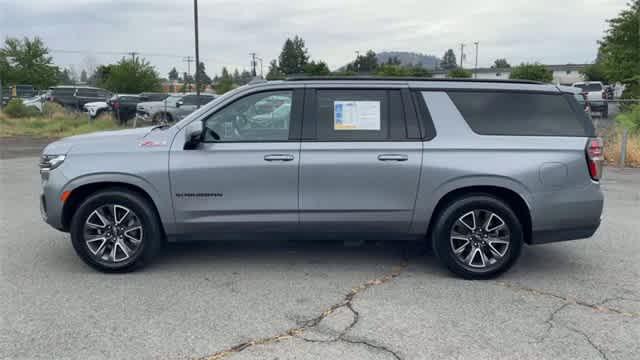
[{"x1": 427, "y1": 185, "x2": 532, "y2": 244}]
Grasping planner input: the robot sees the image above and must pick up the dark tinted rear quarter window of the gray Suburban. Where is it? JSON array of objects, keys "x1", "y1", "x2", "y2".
[{"x1": 448, "y1": 91, "x2": 593, "y2": 137}]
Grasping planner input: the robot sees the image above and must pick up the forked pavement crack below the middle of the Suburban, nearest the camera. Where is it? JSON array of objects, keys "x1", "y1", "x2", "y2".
[{"x1": 199, "y1": 261, "x2": 408, "y2": 360}]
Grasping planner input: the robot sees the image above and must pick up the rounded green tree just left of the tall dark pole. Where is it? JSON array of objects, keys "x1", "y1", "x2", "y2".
[{"x1": 100, "y1": 57, "x2": 162, "y2": 94}]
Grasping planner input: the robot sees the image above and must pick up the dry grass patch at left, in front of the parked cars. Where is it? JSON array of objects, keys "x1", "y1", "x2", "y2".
[{"x1": 0, "y1": 103, "x2": 121, "y2": 138}]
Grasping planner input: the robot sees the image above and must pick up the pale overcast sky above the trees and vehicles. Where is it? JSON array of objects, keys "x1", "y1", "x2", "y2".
[{"x1": 0, "y1": 0, "x2": 627, "y2": 76}]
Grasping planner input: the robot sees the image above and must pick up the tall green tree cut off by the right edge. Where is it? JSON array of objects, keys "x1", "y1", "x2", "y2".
[{"x1": 599, "y1": 0, "x2": 640, "y2": 98}]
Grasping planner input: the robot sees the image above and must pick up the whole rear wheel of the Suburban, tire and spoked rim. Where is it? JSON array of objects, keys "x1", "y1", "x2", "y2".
[{"x1": 432, "y1": 194, "x2": 523, "y2": 279}]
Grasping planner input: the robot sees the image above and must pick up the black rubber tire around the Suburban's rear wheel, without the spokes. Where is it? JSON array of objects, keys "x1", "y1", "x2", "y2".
[{"x1": 431, "y1": 194, "x2": 524, "y2": 280}]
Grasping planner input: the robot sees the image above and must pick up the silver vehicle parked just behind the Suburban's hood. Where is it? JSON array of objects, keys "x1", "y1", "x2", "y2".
[{"x1": 136, "y1": 93, "x2": 215, "y2": 123}]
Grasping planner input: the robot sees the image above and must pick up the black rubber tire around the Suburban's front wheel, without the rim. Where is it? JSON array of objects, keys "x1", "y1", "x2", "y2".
[{"x1": 70, "y1": 188, "x2": 164, "y2": 273}]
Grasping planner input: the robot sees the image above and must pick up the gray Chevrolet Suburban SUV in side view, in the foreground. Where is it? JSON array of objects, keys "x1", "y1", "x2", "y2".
[{"x1": 40, "y1": 78, "x2": 603, "y2": 278}]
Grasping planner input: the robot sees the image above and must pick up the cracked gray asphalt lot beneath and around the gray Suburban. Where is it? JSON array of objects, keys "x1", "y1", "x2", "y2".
[{"x1": 0, "y1": 154, "x2": 640, "y2": 360}]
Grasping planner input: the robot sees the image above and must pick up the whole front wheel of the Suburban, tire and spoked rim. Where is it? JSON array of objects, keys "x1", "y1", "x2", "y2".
[{"x1": 71, "y1": 189, "x2": 162, "y2": 272}]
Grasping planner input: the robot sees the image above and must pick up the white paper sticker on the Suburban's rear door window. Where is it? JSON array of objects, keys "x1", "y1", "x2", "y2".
[{"x1": 333, "y1": 101, "x2": 380, "y2": 130}]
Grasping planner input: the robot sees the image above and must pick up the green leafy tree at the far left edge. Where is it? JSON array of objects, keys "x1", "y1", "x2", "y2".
[{"x1": 0, "y1": 37, "x2": 59, "y2": 89}]
